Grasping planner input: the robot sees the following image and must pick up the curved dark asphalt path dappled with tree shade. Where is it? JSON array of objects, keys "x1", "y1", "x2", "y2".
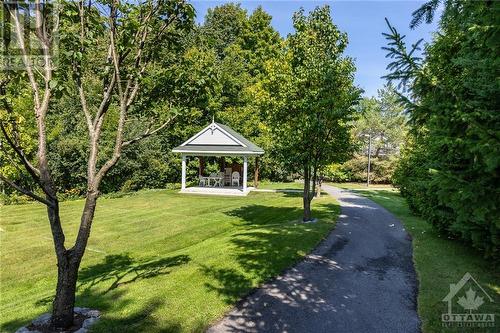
[{"x1": 208, "y1": 186, "x2": 420, "y2": 333}]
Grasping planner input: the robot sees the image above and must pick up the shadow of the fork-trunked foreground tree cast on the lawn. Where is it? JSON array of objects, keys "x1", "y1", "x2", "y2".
[{"x1": 14, "y1": 253, "x2": 190, "y2": 333}]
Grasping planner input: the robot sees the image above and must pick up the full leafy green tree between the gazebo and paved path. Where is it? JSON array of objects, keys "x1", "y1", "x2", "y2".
[{"x1": 258, "y1": 6, "x2": 360, "y2": 220}]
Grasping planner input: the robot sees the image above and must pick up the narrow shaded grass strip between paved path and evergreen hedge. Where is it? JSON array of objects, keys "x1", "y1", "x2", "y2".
[{"x1": 333, "y1": 184, "x2": 500, "y2": 332}]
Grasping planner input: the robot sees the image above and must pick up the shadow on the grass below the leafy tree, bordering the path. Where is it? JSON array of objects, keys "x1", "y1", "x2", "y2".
[{"x1": 201, "y1": 204, "x2": 338, "y2": 304}]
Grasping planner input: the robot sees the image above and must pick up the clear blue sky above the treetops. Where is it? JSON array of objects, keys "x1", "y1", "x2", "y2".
[{"x1": 192, "y1": 0, "x2": 437, "y2": 96}]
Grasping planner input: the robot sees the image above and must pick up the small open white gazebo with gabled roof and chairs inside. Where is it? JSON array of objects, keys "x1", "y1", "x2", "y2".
[{"x1": 172, "y1": 121, "x2": 264, "y2": 195}]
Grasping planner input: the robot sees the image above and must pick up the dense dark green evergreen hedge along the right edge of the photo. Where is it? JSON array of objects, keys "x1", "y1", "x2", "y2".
[{"x1": 394, "y1": 1, "x2": 500, "y2": 260}]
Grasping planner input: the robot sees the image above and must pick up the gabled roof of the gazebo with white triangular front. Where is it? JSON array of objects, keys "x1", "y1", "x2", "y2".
[{"x1": 172, "y1": 121, "x2": 264, "y2": 156}]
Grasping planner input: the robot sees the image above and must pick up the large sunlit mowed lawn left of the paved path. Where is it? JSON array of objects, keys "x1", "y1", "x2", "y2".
[{"x1": 0, "y1": 190, "x2": 338, "y2": 333}]
